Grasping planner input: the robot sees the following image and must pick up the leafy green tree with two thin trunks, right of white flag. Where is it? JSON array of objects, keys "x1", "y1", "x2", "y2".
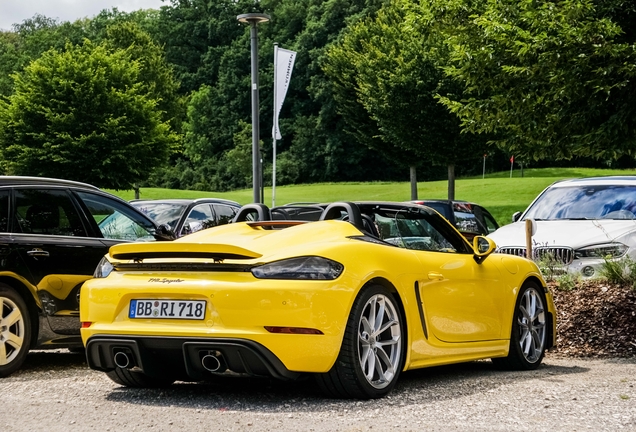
[{"x1": 325, "y1": 0, "x2": 485, "y2": 199}]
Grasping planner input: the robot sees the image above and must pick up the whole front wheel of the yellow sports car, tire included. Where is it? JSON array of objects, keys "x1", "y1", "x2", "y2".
[{"x1": 492, "y1": 281, "x2": 548, "y2": 370}]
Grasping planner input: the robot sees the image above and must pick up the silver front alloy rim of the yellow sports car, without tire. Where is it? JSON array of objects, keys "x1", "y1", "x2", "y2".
[{"x1": 518, "y1": 288, "x2": 546, "y2": 363}]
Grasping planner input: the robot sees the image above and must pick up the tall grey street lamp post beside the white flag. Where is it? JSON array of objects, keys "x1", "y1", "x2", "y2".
[{"x1": 236, "y1": 13, "x2": 269, "y2": 203}]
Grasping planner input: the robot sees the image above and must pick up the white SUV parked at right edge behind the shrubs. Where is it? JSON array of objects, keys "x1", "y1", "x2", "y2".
[{"x1": 490, "y1": 176, "x2": 636, "y2": 278}]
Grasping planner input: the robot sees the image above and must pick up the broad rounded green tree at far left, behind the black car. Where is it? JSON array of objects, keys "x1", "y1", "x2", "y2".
[{"x1": 0, "y1": 41, "x2": 175, "y2": 189}]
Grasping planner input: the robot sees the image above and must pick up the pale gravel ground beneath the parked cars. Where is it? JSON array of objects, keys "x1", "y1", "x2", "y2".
[{"x1": 0, "y1": 350, "x2": 636, "y2": 432}]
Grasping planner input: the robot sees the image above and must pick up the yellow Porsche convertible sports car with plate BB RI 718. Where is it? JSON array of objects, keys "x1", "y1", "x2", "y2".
[{"x1": 80, "y1": 202, "x2": 556, "y2": 399}]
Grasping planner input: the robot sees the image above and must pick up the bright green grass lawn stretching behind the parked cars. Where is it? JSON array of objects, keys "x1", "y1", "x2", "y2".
[{"x1": 109, "y1": 168, "x2": 636, "y2": 225}]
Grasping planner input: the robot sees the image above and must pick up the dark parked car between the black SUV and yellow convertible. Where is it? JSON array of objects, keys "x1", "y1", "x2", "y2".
[{"x1": 130, "y1": 198, "x2": 241, "y2": 237}]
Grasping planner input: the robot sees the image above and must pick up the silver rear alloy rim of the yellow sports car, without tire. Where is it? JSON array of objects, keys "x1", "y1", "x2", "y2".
[{"x1": 358, "y1": 294, "x2": 402, "y2": 389}]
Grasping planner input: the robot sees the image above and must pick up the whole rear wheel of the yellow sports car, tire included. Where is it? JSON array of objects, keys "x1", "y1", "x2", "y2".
[{"x1": 315, "y1": 285, "x2": 406, "y2": 399}]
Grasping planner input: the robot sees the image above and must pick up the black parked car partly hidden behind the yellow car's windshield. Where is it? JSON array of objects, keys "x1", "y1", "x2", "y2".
[{"x1": 411, "y1": 199, "x2": 499, "y2": 240}]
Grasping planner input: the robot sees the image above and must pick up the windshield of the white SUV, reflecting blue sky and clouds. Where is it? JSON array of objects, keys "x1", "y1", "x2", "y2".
[{"x1": 523, "y1": 186, "x2": 636, "y2": 220}]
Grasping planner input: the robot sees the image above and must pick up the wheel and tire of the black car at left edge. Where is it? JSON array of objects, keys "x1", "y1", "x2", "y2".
[{"x1": 0, "y1": 284, "x2": 33, "y2": 378}]
